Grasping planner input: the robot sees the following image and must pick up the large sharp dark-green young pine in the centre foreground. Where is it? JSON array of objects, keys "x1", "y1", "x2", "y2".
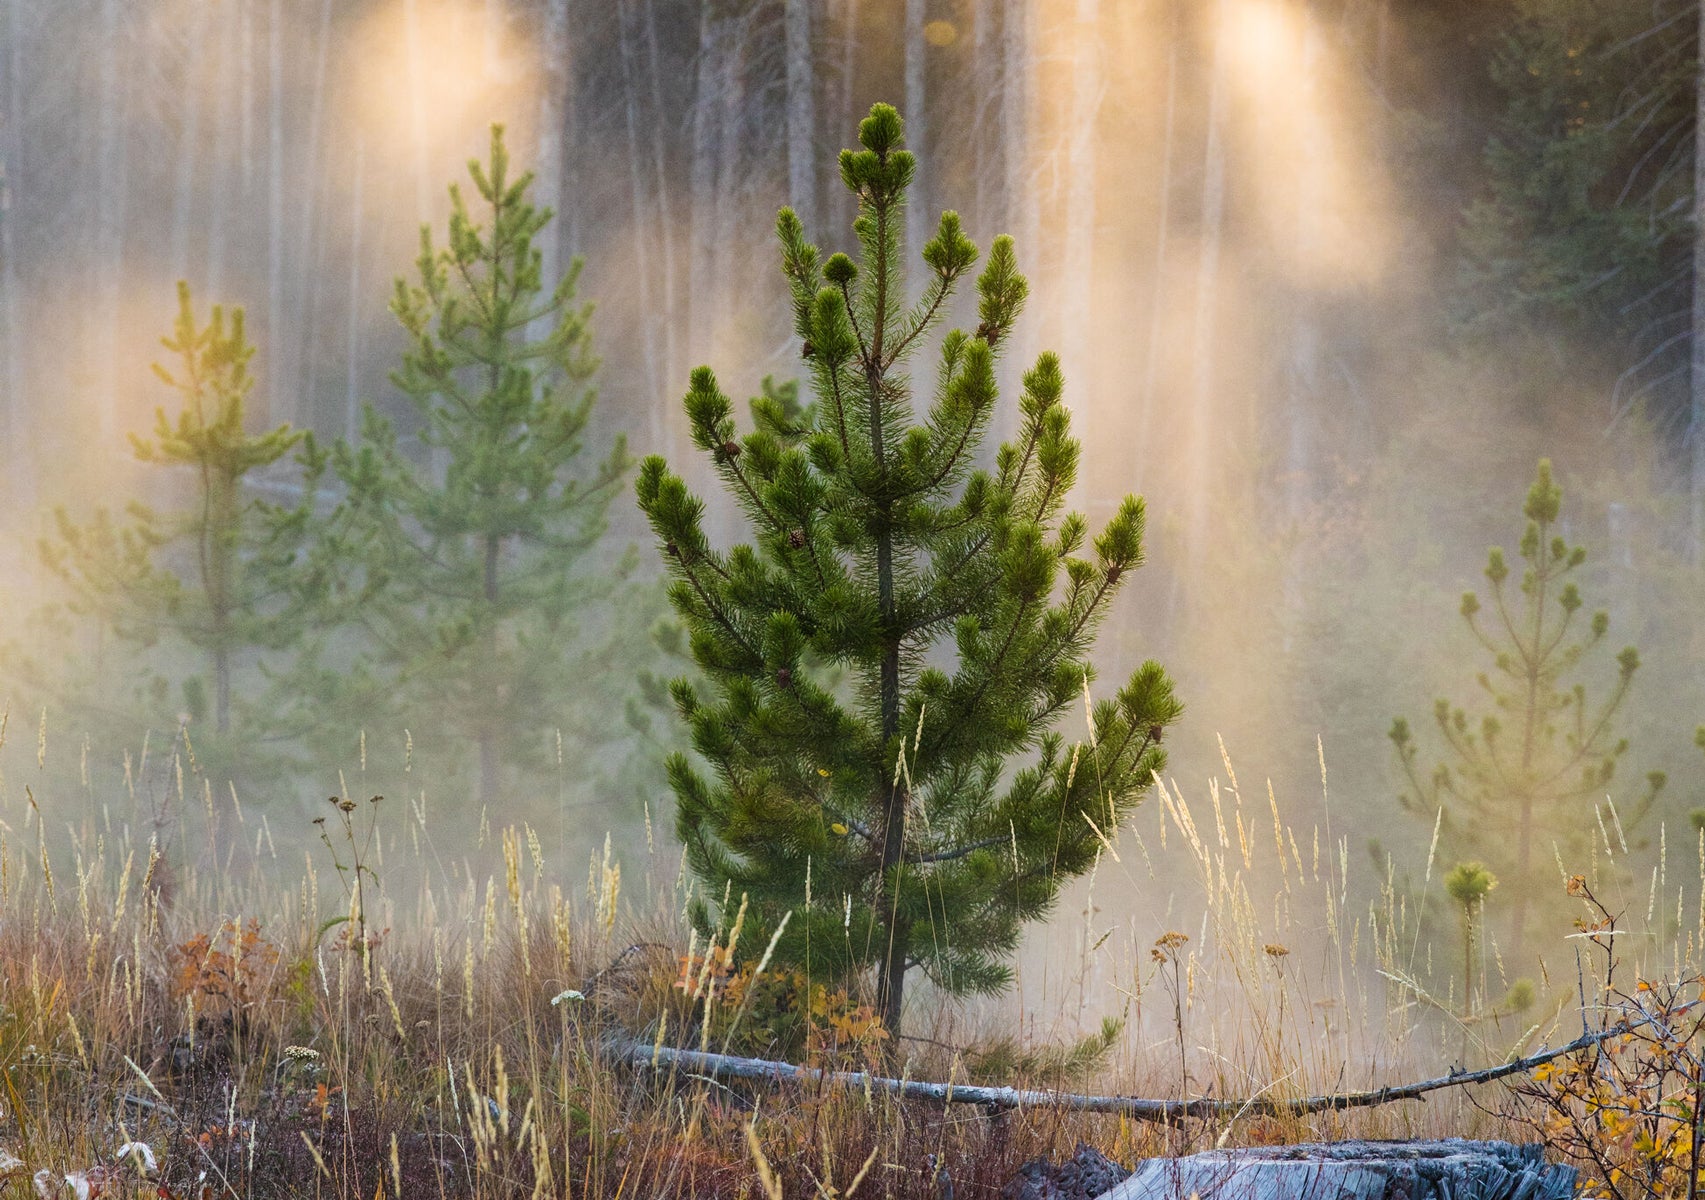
[{"x1": 638, "y1": 104, "x2": 1180, "y2": 1035}]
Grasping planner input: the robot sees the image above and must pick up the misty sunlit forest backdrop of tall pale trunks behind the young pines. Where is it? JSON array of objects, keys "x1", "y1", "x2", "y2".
[{"x1": 0, "y1": 0, "x2": 1705, "y2": 1029}]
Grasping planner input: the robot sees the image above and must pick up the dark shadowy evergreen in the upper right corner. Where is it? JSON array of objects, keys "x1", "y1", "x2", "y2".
[{"x1": 1458, "y1": 0, "x2": 1698, "y2": 424}]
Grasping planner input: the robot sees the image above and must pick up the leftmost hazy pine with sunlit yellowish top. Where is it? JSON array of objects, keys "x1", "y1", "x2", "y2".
[{"x1": 39, "y1": 283, "x2": 322, "y2": 735}]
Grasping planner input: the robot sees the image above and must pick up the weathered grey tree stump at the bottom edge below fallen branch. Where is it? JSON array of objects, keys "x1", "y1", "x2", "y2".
[{"x1": 1101, "y1": 1137, "x2": 1575, "y2": 1200}]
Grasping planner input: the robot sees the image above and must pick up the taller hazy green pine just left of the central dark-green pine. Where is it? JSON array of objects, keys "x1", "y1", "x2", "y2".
[{"x1": 312, "y1": 126, "x2": 644, "y2": 803}]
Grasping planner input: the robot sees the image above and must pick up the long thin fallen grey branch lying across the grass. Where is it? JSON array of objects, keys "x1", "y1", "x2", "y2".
[{"x1": 614, "y1": 1018, "x2": 1650, "y2": 1122}]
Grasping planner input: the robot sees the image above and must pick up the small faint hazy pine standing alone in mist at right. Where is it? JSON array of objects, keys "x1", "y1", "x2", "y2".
[{"x1": 1390, "y1": 459, "x2": 1664, "y2": 944}]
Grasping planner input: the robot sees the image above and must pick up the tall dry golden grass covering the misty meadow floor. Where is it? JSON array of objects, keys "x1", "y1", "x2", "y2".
[{"x1": 0, "y1": 715, "x2": 1677, "y2": 1200}]
